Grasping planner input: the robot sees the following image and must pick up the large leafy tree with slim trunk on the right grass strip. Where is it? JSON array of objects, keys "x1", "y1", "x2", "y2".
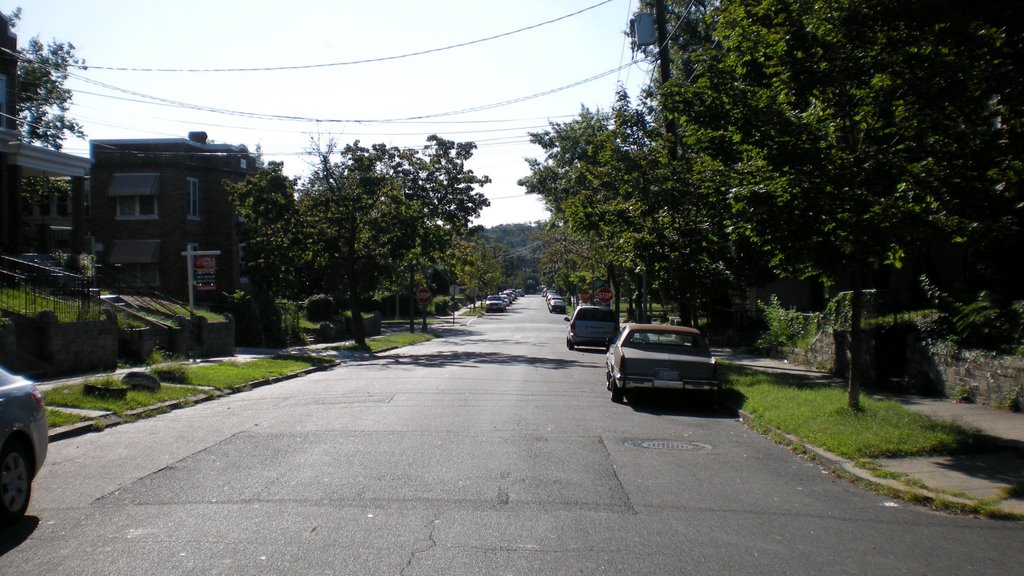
[{"x1": 688, "y1": 0, "x2": 1021, "y2": 409}]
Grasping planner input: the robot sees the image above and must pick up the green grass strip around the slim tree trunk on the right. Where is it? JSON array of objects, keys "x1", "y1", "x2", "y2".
[{"x1": 721, "y1": 364, "x2": 980, "y2": 459}]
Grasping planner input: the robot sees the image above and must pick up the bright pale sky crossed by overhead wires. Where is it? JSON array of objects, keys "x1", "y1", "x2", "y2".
[{"x1": 0, "y1": 0, "x2": 654, "y2": 227}]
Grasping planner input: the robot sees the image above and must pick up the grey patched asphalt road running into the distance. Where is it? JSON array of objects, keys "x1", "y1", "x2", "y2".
[{"x1": 6, "y1": 296, "x2": 1024, "y2": 576}]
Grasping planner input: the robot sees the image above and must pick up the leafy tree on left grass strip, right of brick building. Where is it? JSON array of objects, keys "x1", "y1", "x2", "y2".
[{"x1": 298, "y1": 136, "x2": 489, "y2": 346}]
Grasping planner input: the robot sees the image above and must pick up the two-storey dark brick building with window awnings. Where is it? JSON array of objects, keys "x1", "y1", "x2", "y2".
[{"x1": 86, "y1": 132, "x2": 257, "y2": 299}]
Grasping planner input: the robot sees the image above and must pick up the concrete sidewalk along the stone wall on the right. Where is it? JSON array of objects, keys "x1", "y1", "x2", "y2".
[{"x1": 715, "y1": 348, "x2": 1024, "y2": 519}]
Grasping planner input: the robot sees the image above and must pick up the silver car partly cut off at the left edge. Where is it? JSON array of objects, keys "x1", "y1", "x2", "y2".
[{"x1": 0, "y1": 368, "x2": 49, "y2": 524}]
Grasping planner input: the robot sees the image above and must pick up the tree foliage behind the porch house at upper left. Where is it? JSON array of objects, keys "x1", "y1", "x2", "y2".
[{"x1": 7, "y1": 8, "x2": 85, "y2": 151}]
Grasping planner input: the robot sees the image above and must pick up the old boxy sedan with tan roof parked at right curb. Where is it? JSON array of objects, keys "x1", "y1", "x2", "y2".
[{"x1": 605, "y1": 324, "x2": 721, "y2": 403}]
